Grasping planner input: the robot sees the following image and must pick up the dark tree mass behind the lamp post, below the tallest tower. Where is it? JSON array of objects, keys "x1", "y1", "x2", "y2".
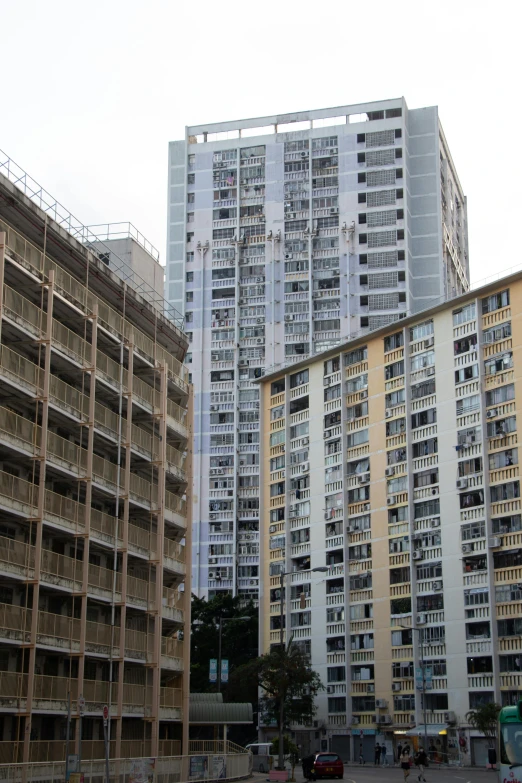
[{"x1": 190, "y1": 594, "x2": 258, "y2": 702}]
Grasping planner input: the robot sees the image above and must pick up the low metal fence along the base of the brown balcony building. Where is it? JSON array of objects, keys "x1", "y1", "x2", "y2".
[{"x1": 0, "y1": 751, "x2": 252, "y2": 783}]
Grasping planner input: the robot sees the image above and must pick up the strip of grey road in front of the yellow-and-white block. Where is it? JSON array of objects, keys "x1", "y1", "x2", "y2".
[{"x1": 253, "y1": 764, "x2": 498, "y2": 783}]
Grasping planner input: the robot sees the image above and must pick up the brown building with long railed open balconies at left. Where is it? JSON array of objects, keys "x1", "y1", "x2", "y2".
[{"x1": 0, "y1": 164, "x2": 192, "y2": 764}]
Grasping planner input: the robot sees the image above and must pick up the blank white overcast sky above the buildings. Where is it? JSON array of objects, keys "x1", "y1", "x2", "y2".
[{"x1": 0, "y1": 0, "x2": 522, "y2": 288}]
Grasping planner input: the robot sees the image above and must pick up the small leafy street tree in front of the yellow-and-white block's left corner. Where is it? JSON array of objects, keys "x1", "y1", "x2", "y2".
[{"x1": 231, "y1": 639, "x2": 323, "y2": 769}]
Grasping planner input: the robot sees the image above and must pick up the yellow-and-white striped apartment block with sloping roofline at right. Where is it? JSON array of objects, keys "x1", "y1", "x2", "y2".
[{"x1": 260, "y1": 273, "x2": 522, "y2": 763}]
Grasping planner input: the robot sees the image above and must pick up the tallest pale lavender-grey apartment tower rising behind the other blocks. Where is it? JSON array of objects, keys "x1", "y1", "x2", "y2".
[{"x1": 166, "y1": 99, "x2": 468, "y2": 597}]
